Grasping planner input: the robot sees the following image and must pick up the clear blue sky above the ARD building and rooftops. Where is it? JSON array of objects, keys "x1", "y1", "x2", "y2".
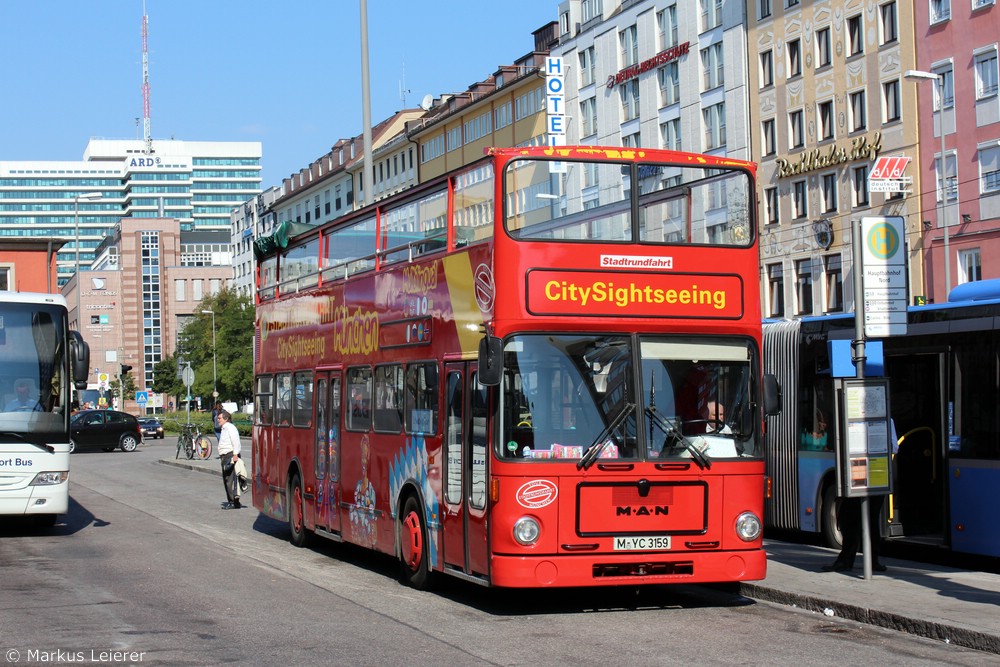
[{"x1": 0, "y1": 0, "x2": 558, "y2": 188}]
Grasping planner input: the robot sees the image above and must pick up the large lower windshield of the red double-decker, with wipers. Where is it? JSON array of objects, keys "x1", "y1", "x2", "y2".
[{"x1": 499, "y1": 334, "x2": 761, "y2": 468}]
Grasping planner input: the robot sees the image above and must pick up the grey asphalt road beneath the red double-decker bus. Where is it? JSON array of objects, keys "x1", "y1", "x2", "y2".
[{"x1": 0, "y1": 438, "x2": 996, "y2": 667}]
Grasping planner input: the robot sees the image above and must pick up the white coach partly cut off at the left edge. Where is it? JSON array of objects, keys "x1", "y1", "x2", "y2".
[{"x1": 0, "y1": 292, "x2": 90, "y2": 526}]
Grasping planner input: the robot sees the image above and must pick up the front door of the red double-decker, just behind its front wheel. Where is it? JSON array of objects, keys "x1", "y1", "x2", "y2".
[{"x1": 442, "y1": 362, "x2": 489, "y2": 577}]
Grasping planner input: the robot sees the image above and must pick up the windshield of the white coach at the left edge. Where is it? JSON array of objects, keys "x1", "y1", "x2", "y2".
[{"x1": 0, "y1": 302, "x2": 69, "y2": 443}]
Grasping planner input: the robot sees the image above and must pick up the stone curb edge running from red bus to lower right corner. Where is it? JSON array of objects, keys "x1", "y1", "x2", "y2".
[{"x1": 739, "y1": 583, "x2": 1000, "y2": 653}]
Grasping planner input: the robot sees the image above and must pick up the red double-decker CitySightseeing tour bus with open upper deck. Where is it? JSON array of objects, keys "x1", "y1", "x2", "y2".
[{"x1": 253, "y1": 146, "x2": 776, "y2": 587}]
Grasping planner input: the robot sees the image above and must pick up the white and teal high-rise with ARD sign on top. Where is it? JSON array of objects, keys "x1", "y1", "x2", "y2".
[{"x1": 0, "y1": 139, "x2": 261, "y2": 285}]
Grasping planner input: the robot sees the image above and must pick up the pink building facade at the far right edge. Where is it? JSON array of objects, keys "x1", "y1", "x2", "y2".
[{"x1": 911, "y1": 0, "x2": 1000, "y2": 301}]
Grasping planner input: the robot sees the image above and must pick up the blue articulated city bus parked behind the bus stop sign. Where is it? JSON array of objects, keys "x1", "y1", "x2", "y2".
[{"x1": 764, "y1": 280, "x2": 1000, "y2": 556}]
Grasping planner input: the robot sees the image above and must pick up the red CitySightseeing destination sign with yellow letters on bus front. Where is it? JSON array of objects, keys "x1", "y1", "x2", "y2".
[{"x1": 527, "y1": 269, "x2": 743, "y2": 319}]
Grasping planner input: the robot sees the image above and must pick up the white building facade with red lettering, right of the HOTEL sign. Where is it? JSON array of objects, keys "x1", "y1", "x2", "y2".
[{"x1": 552, "y1": 0, "x2": 750, "y2": 160}]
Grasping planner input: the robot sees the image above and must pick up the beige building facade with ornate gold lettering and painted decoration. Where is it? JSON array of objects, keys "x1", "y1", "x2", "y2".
[{"x1": 746, "y1": 0, "x2": 928, "y2": 317}]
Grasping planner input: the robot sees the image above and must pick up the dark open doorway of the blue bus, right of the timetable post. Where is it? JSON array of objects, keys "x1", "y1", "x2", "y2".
[{"x1": 885, "y1": 350, "x2": 948, "y2": 544}]
